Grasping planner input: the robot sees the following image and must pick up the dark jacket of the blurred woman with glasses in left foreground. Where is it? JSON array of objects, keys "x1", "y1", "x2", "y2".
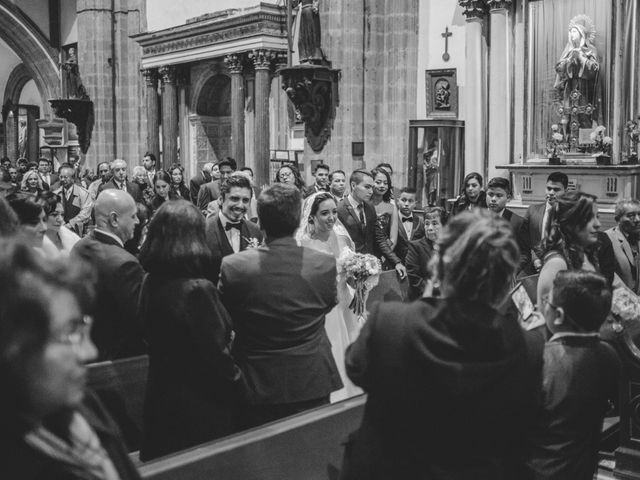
[{"x1": 0, "y1": 392, "x2": 140, "y2": 480}]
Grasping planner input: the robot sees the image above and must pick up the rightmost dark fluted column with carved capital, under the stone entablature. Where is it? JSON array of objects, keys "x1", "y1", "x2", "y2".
[{"x1": 250, "y1": 50, "x2": 274, "y2": 188}]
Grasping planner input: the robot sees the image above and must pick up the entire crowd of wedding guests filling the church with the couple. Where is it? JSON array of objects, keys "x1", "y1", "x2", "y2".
[{"x1": 0, "y1": 154, "x2": 640, "y2": 479}]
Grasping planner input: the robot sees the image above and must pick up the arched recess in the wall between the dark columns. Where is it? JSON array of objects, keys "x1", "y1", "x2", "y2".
[{"x1": 189, "y1": 74, "x2": 231, "y2": 169}]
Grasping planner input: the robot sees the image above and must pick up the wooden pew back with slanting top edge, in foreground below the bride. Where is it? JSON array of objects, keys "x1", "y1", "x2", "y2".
[{"x1": 140, "y1": 395, "x2": 366, "y2": 480}]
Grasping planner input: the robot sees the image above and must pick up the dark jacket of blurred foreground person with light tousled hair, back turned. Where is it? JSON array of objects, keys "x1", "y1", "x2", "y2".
[{"x1": 342, "y1": 298, "x2": 540, "y2": 480}]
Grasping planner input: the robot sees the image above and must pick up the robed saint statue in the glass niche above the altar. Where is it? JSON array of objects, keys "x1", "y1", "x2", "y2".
[{"x1": 554, "y1": 15, "x2": 601, "y2": 139}]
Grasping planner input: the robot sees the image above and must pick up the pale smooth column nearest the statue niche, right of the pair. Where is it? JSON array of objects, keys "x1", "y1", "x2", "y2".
[{"x1": 487, "y1": 0, "x2": 513, "y2": 181}]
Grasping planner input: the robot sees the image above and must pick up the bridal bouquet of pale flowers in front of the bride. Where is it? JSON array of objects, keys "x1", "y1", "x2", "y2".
[{"x1": 338, "y1": 248, "x2": 382, "y2": 319}]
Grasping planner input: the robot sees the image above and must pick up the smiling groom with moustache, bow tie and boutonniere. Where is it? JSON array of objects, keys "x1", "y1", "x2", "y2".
[{"x1": 207, "y1": 173, "x2": 262, "y2": 279}]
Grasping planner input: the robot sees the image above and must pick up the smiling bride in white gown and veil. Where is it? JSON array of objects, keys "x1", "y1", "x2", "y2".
[{"x1": 296, "y1": 192, "x2": 362, "y2": 403}]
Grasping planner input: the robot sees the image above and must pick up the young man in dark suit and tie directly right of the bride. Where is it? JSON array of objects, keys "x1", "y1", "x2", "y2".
[{"x1": 338, "y1": 170, "x2": 376, "y2": 255}]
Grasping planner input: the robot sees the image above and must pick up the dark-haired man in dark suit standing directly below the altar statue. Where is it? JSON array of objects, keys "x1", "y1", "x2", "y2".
[{"x1": 518, "y1": 172, "x2": 569, "y2": 275}]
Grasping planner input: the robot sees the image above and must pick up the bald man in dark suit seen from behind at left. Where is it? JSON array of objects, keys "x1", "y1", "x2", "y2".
[{"x1": 71, "y1": 189, "x2": 145, "y2": 360}]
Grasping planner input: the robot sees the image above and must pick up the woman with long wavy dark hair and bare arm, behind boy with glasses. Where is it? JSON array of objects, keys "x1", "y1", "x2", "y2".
[{"x1": 538, "y1": 192, "x2": 600, "y2": 311}]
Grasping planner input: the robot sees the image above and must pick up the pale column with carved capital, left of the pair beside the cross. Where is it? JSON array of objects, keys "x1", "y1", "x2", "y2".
[{"x1": 459, "y1": 0, "x2": 488, "y2": 176}]
